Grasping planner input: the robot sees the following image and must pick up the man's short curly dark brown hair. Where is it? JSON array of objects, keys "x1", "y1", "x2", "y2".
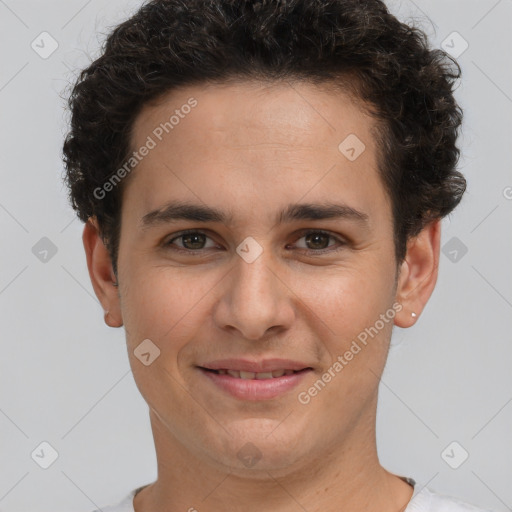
[{"x1": 63, "y1": 0, "x2": 466, "y2": 275}]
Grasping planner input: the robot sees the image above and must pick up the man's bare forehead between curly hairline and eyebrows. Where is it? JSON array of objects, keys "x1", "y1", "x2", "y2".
[{"x1": 123, "y1": 82, "x2": 388, "y2": 224}]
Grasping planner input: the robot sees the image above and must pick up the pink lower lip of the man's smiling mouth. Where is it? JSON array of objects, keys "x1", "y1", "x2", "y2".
[{"x1": 199, "y1": 368, "x2": 313, "y2": 400}]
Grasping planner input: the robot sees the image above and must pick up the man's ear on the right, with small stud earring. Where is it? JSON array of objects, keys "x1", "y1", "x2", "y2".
[{"x1": 395, "y1": 220, "x2": 441, "y2": 327}]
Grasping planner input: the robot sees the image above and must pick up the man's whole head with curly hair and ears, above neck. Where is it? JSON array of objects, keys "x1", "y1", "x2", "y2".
[{"x1": 64, "y1": 0, "x2": 465, "y2": 469}]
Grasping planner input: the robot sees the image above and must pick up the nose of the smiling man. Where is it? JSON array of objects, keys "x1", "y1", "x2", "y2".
[{"x1": 214, "y1": 249, "x2": 295, "y2": 341}]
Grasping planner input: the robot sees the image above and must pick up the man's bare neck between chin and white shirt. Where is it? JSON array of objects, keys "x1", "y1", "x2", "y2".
[{"x1": 134, "y1": 402, "x2": 413, "y2": 512}]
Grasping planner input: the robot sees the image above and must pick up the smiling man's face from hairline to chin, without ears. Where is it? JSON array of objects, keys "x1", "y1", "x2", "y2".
[{"x1": 86, "y1": 83, "x2": 438, "y2": 472}]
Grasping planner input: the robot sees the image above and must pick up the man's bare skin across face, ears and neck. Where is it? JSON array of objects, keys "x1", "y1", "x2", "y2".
[{"x1": 83, "y1": 82, "x2": 440, "y2": 512}]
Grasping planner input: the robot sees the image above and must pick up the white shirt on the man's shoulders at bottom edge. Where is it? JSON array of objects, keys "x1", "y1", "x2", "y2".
[{"x1": 93, "y1": 477, "x2": 492, "y2": 512}]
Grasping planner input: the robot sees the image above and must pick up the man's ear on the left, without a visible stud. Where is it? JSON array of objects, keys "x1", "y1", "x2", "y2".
[{"x1": 82, "y1": 217, "x2": 123, "y2": 327}]
